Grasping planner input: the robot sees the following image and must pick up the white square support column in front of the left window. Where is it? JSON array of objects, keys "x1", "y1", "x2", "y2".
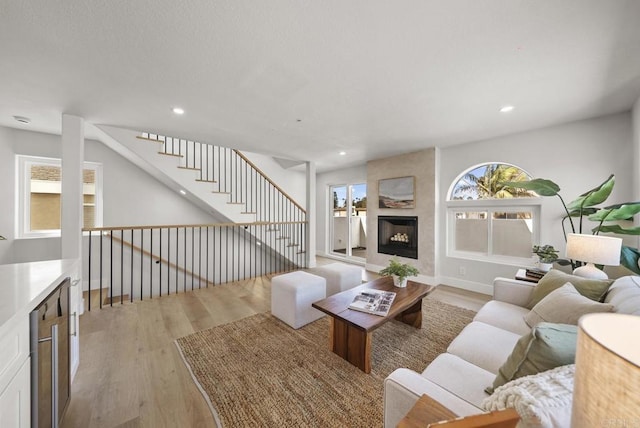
[{"x1": 60, "y1": 114, "x2": 84, "y2": 259}]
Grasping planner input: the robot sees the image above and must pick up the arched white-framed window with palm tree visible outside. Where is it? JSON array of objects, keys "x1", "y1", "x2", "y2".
[{"x1": 447, "y1": 163, "x2": 540, "y2": 264}]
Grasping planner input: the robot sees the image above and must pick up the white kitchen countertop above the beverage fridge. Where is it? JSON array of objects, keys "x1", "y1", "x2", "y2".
[{"x1": 0, "y1": 260, "x2": 78, "y2": 336}]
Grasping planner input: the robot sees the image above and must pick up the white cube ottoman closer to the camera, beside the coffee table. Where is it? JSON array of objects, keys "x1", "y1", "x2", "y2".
[{"x1": 271, "y1": 271, "x2": 326, "y2": 329}]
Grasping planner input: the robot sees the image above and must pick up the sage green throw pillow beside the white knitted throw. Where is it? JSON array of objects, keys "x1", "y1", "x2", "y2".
[{"x1": 485, "y1": 322, "x2": 578, "y2": 394}]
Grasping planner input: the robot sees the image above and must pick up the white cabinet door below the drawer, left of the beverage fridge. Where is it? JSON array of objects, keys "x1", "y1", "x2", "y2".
[{"x1": 0, "y1": 358, "x2": 31, "y2": 428}]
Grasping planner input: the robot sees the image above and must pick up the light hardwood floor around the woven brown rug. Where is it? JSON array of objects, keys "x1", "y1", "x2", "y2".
[{"x1": 62, "y1": 259, "x2": 489, "y2": 428}]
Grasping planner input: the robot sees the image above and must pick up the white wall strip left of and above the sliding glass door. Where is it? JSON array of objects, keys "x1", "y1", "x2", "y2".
[{"x1": 316, "y1": 165, "x2": 367, "y2": 255}]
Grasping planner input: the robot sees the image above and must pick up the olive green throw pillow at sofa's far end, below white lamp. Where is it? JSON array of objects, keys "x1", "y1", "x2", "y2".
[{"x1": 527, "y1": 269, "x2": 613, "y2": 309}]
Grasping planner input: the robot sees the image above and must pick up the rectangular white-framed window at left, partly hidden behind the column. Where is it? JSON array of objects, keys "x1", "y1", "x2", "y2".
[{"x1": 16, "y1": 155, "x2": 102, "y2": 238}]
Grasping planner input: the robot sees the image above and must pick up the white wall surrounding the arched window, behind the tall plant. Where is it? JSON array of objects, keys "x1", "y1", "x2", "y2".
[{"x1": 437, "y1": 112, "x2": 637, "y2": 291}]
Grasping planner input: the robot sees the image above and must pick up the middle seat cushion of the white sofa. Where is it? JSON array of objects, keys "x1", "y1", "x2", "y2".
[{"x1": 447, "y1": 321, "x2": 522, "y2": 374}]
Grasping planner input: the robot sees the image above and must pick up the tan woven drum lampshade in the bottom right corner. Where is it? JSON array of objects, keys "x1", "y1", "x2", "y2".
[{"x1": 571, "y1": 313, "x2": 640, "y2": 428}]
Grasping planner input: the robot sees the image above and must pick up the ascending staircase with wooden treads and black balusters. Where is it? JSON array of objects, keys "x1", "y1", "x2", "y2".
[{"x1": 92, "y1": 125, "x2": 306, "y2": 261}]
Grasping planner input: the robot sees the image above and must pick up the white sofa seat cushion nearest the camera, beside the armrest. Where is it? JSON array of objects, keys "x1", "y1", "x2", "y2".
[{"x1": 422, "y1": 353, "x2": 496, "y2": 407}]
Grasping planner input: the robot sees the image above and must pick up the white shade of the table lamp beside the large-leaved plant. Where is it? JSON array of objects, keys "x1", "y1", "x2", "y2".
[{"x1": 566, "y1": 233, "x2": 622, "y2": 266}]
